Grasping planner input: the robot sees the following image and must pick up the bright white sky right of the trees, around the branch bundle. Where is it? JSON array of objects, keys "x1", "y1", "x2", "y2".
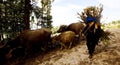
[{"x1": 51, "y1": 0, "x2": 120, "y2": 26}]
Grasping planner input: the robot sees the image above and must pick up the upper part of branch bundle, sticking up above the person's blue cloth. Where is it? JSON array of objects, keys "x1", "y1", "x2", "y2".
[{"x1": 78, "y1": 5, "x2": 103, "y2": 23}]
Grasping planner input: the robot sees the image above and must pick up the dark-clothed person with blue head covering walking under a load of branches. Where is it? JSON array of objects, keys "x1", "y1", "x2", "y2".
[{"x1": 82, "y1": 16, "x2": 100, "y2": 58}]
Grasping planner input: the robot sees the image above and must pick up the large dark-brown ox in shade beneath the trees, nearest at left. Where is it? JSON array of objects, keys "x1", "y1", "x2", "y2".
[{"x1": 7, "y1": 28, "x2": 52, "y2": 57}]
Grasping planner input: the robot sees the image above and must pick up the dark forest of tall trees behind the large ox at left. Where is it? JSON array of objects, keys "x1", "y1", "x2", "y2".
[{"x1": 0, "y1": 0, "x2": 53, "y2": 40}]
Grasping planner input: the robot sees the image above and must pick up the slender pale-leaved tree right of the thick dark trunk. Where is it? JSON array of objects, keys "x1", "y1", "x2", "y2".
[{"x1": 41, "y1": 0, "x2": 53, "y2": 28}]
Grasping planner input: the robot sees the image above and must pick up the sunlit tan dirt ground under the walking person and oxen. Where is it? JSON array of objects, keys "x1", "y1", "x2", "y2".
[{"x1": 12, "y1": 29, "x2": 120, "y2": 65}]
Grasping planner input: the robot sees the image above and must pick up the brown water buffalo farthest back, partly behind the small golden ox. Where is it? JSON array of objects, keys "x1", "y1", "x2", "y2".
[{"x1": 57, "y1": 22, "x2": 84, "y2": 41}]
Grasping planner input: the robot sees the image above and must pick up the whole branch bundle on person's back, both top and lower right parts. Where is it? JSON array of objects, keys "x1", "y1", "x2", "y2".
[{"x1": 77, "y1": 5, "x2": 110, "y2": 45}]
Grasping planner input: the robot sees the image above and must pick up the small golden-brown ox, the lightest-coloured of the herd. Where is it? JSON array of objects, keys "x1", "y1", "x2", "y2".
[{"x1": 52, "y1": 31, "x2": 75, "y2": 49}]
